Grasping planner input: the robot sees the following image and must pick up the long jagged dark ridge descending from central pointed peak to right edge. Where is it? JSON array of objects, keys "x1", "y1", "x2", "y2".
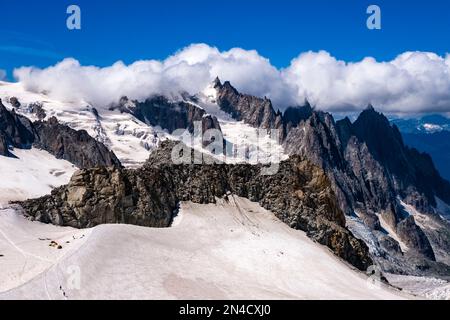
[{"x1": 211, "y1": 79, "x2": 450, "y2": 268}]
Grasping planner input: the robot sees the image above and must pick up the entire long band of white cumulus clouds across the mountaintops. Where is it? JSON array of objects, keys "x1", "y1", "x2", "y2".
[{"x1": 14, "y1": 44, "x2": 450, "y2": 113}]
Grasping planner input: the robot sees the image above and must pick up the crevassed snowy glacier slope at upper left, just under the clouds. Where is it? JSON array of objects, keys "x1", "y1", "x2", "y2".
[{"x1": 0, "y1": 81, "x2": 166, "y2": 166}]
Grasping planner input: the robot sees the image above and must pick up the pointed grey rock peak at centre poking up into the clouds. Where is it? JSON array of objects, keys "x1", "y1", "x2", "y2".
[{"x1": 214, "y1": 79, "x2": 282, "y2": 129}]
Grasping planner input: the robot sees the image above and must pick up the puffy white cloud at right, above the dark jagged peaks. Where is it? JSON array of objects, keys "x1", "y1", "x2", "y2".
[{"x1": 282, "y1": 51, "x2": 450, "y2": 113}]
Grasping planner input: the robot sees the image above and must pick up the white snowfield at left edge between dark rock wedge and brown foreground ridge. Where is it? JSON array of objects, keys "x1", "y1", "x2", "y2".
[{"x1": 0, "y1": 149, "x2": 77, "y2": 208}]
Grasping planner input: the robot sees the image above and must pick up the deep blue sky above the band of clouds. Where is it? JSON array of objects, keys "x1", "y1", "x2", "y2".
[{"x1": 0, "y1": 0, "x2": 450, "y2": 77}]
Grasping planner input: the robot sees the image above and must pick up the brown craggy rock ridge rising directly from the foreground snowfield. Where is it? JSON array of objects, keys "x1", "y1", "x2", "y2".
[{"x1": 21, "y1": 142, "x2": 372, "y2": 270}]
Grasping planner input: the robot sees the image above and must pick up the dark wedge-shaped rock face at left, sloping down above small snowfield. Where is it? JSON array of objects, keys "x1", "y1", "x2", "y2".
[{"x1": 34, "y1": 117, "x2": 120, "y2": 168}]
